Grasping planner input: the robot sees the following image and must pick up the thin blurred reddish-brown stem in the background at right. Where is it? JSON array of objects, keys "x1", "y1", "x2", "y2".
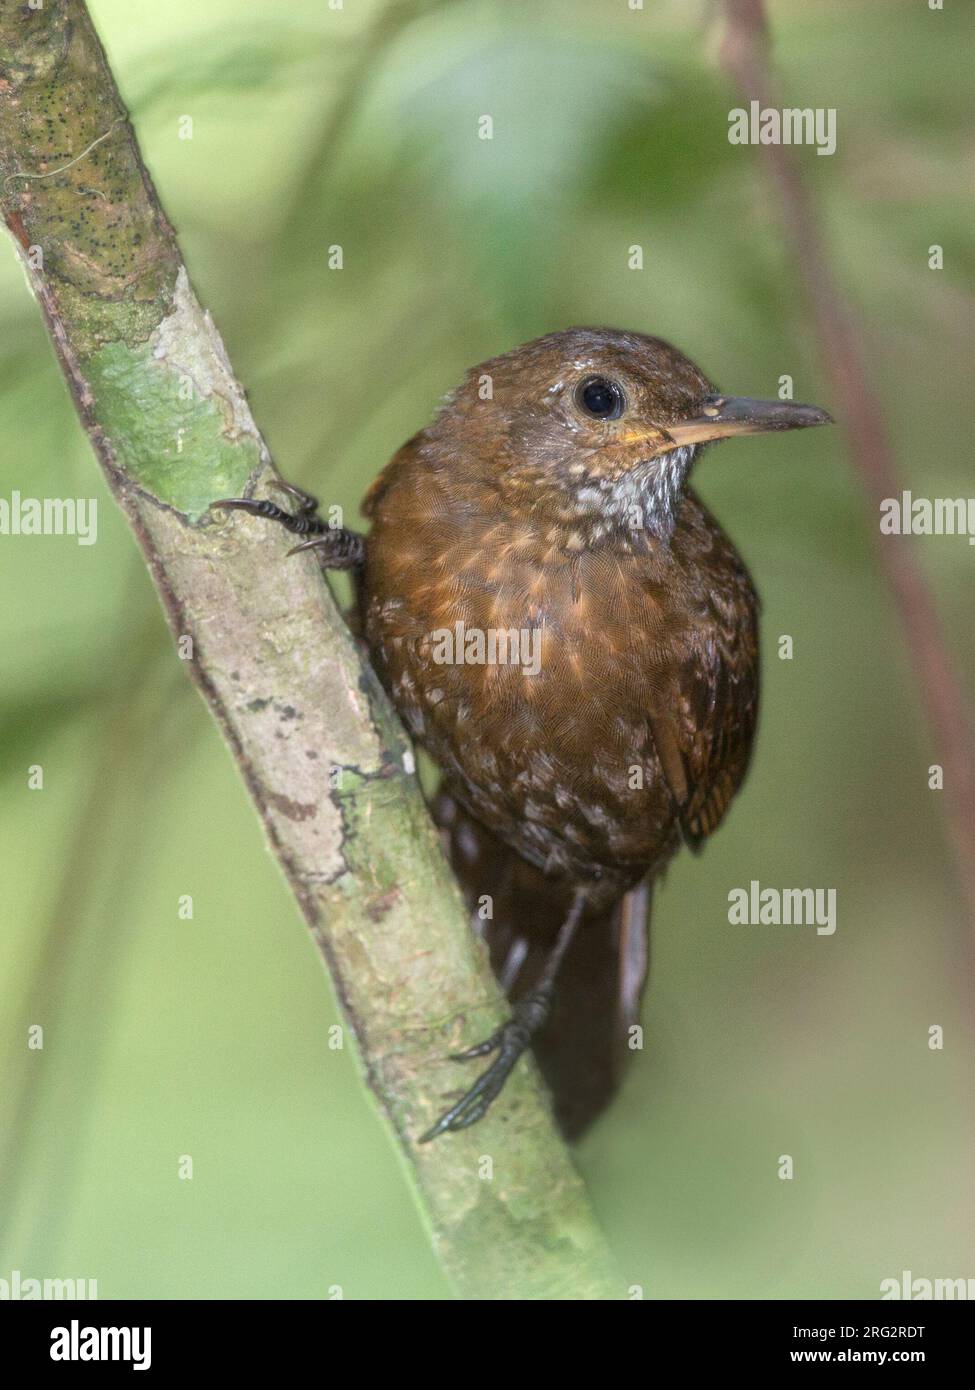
[{"x1": 720, "y1": 0, "x2": 975, "y2": 923}]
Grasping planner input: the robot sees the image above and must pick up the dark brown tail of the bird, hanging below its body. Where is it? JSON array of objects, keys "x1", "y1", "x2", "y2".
[{"x1": 434, "y1": 792, "x2": 650, "y2": 1138}]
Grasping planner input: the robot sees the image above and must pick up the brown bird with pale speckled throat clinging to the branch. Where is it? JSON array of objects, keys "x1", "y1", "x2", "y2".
[{"x1": 217, "y1": 328, "x2": 830, "y2": 1141}]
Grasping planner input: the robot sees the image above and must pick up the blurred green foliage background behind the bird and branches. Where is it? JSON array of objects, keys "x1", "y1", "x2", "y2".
[{"x1": 0, "y1": 0, "x2": 975, "y2": 1300}]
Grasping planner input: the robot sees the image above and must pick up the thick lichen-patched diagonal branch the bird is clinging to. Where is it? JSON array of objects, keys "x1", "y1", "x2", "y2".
[{"x1": 0, "y1": 0, "x2": 623, "y2": 1300}]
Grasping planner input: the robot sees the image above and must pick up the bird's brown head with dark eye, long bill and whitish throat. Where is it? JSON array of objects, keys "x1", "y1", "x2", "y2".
[{"x1": 428, "y1": 328, "x2": 830, "y2": 538}]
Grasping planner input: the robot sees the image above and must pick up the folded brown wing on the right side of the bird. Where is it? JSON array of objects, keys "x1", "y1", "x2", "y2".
[{"x1": 650, "y1": 495, "x2": 758, "y2": 849}]
